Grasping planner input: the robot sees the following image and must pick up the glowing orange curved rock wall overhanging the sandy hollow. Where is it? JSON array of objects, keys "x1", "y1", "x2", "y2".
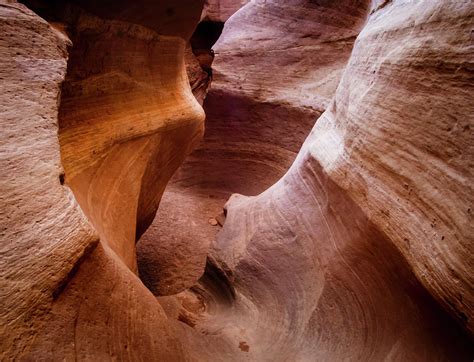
[{"x1": 59, "y1": 3, "x2": 203, "y2": 270}]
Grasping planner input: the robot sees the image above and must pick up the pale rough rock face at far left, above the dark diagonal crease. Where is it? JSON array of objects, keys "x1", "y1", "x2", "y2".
[{"x1": 0, "y1": 3, "x2": 98, "y2": 358}]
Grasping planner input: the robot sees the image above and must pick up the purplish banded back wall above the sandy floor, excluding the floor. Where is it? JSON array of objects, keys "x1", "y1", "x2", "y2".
[{"x1": 200, "y1": 1, "x2": 367, "y2": 194}]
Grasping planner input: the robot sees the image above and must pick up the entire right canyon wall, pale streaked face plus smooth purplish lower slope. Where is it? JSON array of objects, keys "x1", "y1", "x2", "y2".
[{"x1": 182, "y1": 2, "x2": 473, "y2": 360}]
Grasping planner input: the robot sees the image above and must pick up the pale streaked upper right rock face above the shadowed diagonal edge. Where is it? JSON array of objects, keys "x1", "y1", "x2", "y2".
[{"x1": 307, "y1": 2, "x2": 474, "y2": 332}]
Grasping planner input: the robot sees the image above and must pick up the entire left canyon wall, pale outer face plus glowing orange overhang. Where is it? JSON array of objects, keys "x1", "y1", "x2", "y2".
[{"x1": 1, "y1": 1, "x2": 204, "y2": 360}]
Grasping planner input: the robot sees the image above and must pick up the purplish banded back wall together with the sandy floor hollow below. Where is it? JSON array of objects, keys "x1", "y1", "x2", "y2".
[{"x1": 138, "y1": 1, "x2": 368, "y2": 295}]
